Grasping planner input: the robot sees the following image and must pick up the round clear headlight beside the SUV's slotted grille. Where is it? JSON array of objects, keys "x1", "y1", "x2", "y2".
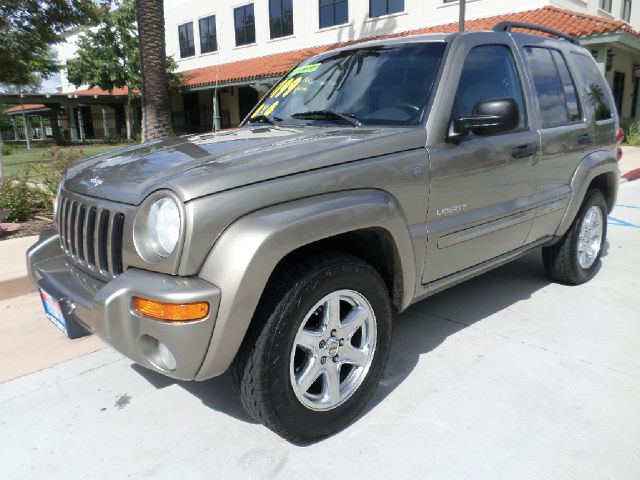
[{"x1": 147, "y1": 197, "x2": 180, "y2": 258}]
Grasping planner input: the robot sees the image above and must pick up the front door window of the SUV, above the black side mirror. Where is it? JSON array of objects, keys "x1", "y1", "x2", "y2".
[{"x1": 453, "y1": 45, "x2": 527, "y2": 129}]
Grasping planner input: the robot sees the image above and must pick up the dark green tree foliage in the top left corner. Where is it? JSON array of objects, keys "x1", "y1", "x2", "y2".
[{"x1": 0, "y1": 0, "x2": 103, "y2": 85}]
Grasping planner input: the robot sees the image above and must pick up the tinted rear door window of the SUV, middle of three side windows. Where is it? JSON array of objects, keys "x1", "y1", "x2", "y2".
[{"x1": 524, "y1": 47, "x2": 580, "y2": 128}]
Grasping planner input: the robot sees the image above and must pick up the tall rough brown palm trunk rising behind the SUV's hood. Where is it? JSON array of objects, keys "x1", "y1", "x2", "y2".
[{"x1": 136, "y1": 0, "x2": 171, "y2": 142}]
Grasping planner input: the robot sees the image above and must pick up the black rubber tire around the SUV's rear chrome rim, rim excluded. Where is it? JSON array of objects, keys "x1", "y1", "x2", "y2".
[{"x1": 542, "y1": 190, "x2": 607, "y2": 285}]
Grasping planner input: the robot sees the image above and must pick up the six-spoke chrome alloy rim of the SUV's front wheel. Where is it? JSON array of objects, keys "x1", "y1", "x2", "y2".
[{"x1": 289, "y1": 290, "x2": 377, "y2": 410}]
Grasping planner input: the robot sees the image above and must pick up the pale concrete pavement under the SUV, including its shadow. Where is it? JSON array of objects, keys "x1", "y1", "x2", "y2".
[{"x1": 0, "y1": 182, "x2": 640, "y2": 480}]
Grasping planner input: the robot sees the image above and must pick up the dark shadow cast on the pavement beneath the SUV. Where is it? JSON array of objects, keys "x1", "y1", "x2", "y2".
[{"x1": 131, "y1": 249, "x2": 572, "y2": 436}]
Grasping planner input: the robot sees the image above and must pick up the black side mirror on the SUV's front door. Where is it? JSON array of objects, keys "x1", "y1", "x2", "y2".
[{"x1": 449, "y1": 98, "x2": 520, "y2": 141}]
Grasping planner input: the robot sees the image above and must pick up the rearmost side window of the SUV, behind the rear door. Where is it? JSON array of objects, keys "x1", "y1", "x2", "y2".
[{"x1": 571, "y1": 52, "x2": 613, "y2": 120}]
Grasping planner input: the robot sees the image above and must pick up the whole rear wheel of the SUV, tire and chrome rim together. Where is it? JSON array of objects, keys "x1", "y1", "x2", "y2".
[{"x1": 542, "y1": 190, "x2": 607, "y2": 285}]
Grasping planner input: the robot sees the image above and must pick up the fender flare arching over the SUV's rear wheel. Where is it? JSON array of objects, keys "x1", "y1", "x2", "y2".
[{"x1": 555, "y1": 150, "x2": 620, "y2": 237}]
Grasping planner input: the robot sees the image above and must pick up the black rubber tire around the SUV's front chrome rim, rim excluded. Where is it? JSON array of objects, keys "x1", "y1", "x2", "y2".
[{"x1": 232, "y1": 253, "x2": 392, "y2": 444}]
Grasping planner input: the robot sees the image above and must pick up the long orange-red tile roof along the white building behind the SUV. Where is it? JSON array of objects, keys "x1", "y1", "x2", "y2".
[{"x1": 182, "y1": 6, "x2": 640, "y2": 87}]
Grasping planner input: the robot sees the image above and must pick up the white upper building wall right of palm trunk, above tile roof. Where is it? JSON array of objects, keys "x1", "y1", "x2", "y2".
[{"x1": 164, "y1": 0, "x2": 549, "y2": 71}]
